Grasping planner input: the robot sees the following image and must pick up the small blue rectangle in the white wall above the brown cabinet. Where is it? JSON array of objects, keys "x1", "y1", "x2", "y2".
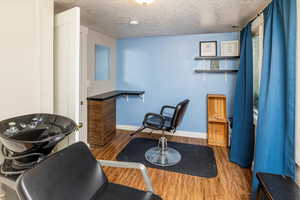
[{"x1": 95, "y1": 45, "x2": 110, "y2": 81}]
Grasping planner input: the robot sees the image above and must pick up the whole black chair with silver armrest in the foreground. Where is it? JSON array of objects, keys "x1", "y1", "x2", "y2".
[{"x1": 17, "y1": 142, "x2": 161, "y2": 200}]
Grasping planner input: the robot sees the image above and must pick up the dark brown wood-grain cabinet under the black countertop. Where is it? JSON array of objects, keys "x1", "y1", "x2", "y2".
[{"x1": 88, "y1": 98, "x2": 116, "y2": 148}]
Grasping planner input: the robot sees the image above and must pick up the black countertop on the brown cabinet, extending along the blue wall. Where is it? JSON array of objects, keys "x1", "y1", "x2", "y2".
[{"x1": 87, "y1": 90, "x2": 145, "y2": 101}]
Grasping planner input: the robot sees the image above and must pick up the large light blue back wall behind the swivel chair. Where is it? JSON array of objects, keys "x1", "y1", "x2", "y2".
[{"x1": 117, "y1": 33, "x2": 239, "y2": 132}]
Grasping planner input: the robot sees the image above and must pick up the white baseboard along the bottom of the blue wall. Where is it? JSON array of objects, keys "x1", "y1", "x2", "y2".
[{"x1": 117, "y1": 124, "x2": 207, "y2": 139}]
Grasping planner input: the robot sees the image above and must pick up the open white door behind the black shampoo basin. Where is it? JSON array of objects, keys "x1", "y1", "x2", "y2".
[{"x1": 54, "y1": 8, "x2": 81, "y2": 148}]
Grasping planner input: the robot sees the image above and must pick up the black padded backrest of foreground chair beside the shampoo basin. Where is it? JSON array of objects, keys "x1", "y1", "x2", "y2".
[{"x1": 17, "y1": 142, "x2": 107, "y2": 200}]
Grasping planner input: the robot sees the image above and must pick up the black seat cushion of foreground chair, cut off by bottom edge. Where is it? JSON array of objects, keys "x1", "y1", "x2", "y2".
[{"x1": 91, "y1": 183, "x2": 162, "y2": 200}]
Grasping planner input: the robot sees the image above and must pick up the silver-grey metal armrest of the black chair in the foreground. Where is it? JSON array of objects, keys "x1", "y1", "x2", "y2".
[{"x1": 98, "y1": 160, "x2": 153, "y2": 193}]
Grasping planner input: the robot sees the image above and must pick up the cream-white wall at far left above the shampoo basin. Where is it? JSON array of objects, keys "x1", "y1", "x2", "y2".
[{"x1": 0, "y1": 0, "x2": 53, "y2": 120}]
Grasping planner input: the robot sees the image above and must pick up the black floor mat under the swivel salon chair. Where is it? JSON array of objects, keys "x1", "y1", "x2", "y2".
[{"x1": 117, "y1": 138, "x2": 218, "y2": 178}]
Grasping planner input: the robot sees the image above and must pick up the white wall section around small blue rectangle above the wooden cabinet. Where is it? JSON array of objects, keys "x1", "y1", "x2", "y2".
[{"x1": 87, "y1": 29, "x2": 116, "y2": 96}]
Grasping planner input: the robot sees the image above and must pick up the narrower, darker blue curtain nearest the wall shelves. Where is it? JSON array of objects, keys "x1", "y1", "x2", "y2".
[{"x1": 230, "y1": 23, "x2": 254, "y2": 167}]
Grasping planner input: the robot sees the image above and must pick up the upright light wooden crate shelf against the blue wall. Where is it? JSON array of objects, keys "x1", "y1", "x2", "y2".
[{"x1": 207, "y1": 95, "x2": 228, "y2": 147}]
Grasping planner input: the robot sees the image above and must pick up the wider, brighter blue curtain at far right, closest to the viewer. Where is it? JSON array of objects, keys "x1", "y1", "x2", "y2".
[{"x1": 253, "y1": 0, "x2": 297, "y2": 198}]
